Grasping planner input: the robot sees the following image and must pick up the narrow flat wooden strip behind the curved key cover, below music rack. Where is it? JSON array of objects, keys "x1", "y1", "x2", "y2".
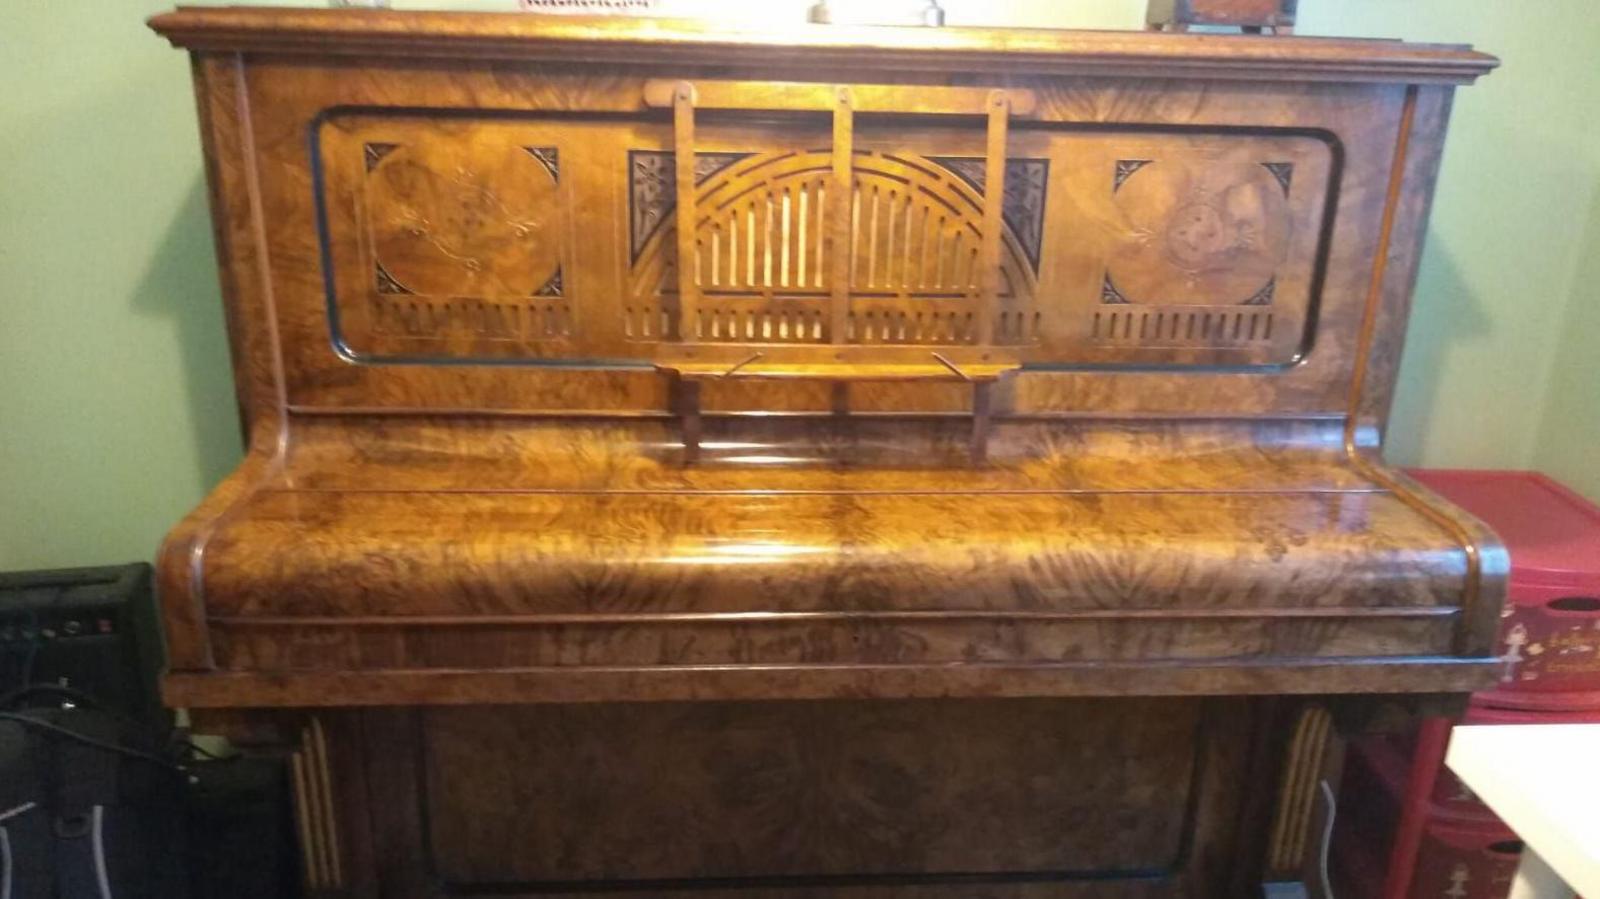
[{"x1": 272, "y1": 414, "x2": 1382, "y2": 494}]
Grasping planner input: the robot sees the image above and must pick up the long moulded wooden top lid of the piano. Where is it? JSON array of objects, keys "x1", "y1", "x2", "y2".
[{"x1": 149, "y1": 6, "x2": 1499, "y2": 83}]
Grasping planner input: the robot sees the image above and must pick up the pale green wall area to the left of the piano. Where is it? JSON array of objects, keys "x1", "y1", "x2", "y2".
[{"x1": 0, "y1": 0, "x2": 240, "y2": 569}]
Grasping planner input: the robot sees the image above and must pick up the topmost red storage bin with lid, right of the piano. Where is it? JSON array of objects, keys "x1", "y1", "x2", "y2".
[{"x1": 1408, "y1": 470, "x2": 1600, "y2": 700}]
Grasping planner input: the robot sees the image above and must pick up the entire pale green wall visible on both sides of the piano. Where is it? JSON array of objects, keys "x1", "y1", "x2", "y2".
[{"x1": 0, "y1": 0, "x2": 1600, "y2": 568}]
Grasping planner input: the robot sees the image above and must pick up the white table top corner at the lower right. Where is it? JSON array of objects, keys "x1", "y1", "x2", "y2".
[{"x1": 1445, "y1": 725, "x2": 1600, "y2": 896}]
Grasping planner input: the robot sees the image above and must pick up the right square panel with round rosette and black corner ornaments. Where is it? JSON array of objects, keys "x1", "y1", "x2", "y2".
[{"x1": 1082, "y1": 136, "x2": 1331, "y2": 362}]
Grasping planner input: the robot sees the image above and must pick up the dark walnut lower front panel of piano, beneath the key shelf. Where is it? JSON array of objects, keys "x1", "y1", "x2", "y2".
[{"x1": 422, "y1": 701, "x2": 1203, "y2": 883}]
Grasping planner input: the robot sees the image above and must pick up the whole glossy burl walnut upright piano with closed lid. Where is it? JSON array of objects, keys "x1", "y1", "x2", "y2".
[{"x1": 152, "y1": 8, "x2": 1506, "y2": 899}]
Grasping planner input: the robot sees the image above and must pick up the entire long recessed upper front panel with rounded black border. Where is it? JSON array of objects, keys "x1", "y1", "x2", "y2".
[{"x1": 315, "y1": 112, "x2": 1338, "y2": 366}]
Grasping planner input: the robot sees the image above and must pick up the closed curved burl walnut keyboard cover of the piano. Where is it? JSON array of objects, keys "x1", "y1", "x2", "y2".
[{"x1": 159, "y1": 416, "x2": 1483, "y2": 704}]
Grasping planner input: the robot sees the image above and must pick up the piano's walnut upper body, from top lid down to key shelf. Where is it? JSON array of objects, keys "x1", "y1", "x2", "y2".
[{"x1": 144, "y1": 10, "x2": 1502, "y2": 704}]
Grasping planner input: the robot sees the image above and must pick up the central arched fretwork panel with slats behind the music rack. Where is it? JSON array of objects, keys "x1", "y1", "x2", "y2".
[{"x1": 626, "y1": 131, "x2": 1050, "y2": 344}]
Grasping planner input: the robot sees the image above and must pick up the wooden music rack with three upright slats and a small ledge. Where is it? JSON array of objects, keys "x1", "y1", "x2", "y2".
[{"x1": 645, "y1": 80, "x2": 1035, "y2": 465}]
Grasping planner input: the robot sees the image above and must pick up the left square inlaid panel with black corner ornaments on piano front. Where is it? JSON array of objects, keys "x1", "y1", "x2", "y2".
[{"x1": 318, "y1": 117, "x2": 578, "y2": 360}]
